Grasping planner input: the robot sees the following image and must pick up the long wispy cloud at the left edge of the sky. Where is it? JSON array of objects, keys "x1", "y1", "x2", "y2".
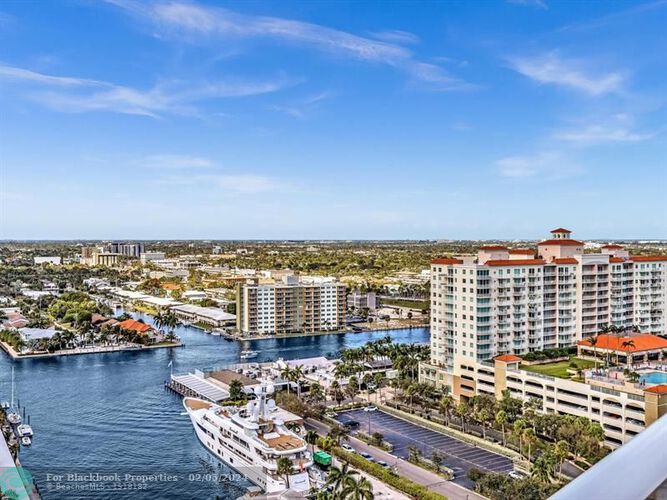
[{"x1": 0, "y1": 65, "x2": 294, "y2": 117}]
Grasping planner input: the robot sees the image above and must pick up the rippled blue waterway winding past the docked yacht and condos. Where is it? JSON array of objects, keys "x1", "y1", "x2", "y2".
[{"x1": 0, "y1": 315, "x2": 429, "y2": 500}]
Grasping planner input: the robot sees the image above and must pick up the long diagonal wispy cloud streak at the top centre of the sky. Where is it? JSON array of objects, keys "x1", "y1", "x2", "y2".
[{"x1": 108, "y1": 0, "x2": 474, "y2": 90}]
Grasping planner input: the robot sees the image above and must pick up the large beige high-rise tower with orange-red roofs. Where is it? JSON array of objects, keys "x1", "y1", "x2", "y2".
[{"x1": 425, "y1": 228, "x2": 667, "y2": 374}]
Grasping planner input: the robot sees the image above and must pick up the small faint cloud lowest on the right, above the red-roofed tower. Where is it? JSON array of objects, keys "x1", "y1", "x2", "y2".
[{"x1": 495, "y1": 151, "x2": 583, "y2": 179}]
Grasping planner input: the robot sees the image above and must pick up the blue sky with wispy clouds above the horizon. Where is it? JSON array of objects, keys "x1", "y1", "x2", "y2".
[{"x1": 0, "y1": 0, "x2": 667, "y2": 239}]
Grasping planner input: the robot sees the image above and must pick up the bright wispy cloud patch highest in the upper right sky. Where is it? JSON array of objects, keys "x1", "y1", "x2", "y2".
[{"x1": 510, "y1": 51, "x2": 625, "y2": 96}]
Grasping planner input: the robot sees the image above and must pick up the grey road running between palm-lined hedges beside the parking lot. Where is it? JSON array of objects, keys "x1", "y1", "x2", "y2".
[{"x1": 306, "y1": 418, "x2": 484, "y2": 500}]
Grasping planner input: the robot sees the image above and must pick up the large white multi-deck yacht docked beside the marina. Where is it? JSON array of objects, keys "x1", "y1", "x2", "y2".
[{"x1": 183, "y1": 383, "x2": 313, "y2": 493}]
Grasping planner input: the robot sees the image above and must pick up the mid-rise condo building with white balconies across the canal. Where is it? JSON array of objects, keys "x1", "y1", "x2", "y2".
[{"x1": 236, "y1": 275, "x2": 346, "y2": 335}]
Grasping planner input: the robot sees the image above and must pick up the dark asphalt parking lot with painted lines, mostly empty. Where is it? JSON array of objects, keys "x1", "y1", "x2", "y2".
[{"x1": 336, "y1": 410, "x2": 513, "y2": 488}]
